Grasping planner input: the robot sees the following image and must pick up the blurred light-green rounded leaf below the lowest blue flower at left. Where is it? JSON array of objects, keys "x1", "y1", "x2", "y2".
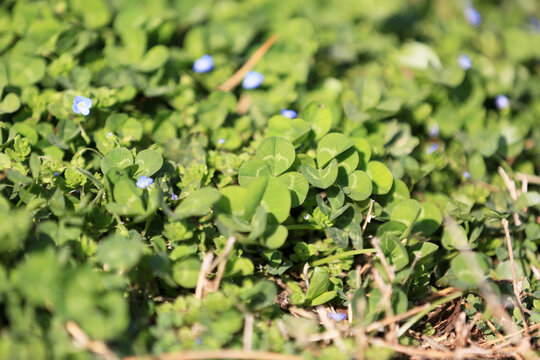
[{"x1": 96, "y1": 235, "x2": 143, "y2": 271}]
